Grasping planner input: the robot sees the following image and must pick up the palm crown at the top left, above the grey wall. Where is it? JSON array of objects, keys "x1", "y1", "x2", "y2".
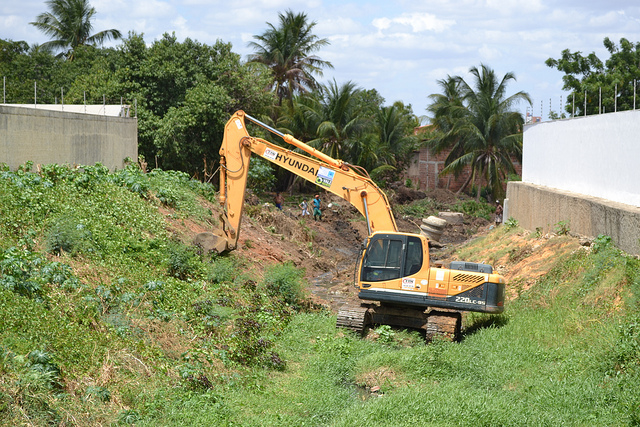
[{"x1": 30, "y1": 0, "x2": 122, "y2": 60}]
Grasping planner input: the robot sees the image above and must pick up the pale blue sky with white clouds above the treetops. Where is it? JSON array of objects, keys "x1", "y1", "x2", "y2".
[{"x1": 0, "y1": 0, "x2": 640, "y2": 120}]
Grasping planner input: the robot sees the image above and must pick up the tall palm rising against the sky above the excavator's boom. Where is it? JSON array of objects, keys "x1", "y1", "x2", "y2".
[{"x1": 249, "y1": 10, "x2": 333, "y2": 105}]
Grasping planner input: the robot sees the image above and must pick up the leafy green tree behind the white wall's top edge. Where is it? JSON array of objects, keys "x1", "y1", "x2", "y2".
[{"x1": 545, "y1": 37, "x2": 640, "y2": 115}]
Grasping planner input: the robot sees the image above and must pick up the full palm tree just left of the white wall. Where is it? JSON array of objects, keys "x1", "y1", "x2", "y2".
[{"x1": 428, "y1": 64, "x2": 531, "y2": 198}]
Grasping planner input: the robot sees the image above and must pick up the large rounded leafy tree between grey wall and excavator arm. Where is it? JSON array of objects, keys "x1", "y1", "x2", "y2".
[{"x1": 64, "y1": 33, "x2": 275, "y2": 177}]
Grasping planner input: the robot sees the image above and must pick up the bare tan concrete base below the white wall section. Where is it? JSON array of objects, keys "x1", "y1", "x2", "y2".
[{"x1": 506, "y1": 182, "x2": 640, "y2": 255}]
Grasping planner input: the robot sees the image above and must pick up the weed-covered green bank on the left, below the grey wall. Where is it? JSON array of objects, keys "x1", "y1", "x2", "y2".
[{"x1": 0, "y1": 164, "x2": 303, "y2": 425}]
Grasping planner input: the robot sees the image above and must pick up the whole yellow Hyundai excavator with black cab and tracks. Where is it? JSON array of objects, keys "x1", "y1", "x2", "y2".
[{"x1": 195, "y1": 111, "x2": 505, "y2": 339}]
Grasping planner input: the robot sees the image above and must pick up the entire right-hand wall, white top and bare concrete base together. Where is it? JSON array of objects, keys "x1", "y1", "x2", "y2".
[{"x1": 504, "y1": 111, "x2": 640, "y2": 254}]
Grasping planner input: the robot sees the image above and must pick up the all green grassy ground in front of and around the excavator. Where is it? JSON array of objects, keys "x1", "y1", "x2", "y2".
[{"x1": 0, "y1": 167, "x2": 640, "y2": 426}]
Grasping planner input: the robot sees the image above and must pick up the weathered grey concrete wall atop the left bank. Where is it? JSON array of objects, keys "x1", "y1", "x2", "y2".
[{"x1": 0, "y1": 105, "x2": 138, "y2": 170}]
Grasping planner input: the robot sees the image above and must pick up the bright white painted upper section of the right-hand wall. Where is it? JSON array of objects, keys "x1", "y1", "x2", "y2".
[{"x1": 522, "y1": 110, "x2": 640, "y2": 206}]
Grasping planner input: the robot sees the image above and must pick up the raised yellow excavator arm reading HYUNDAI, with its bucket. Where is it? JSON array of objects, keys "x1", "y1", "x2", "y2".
[{"x1": 196, "y1": 111, "x2": 397, "y2": 252}]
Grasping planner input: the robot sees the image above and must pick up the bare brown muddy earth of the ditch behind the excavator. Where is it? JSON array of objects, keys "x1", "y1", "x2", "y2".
[{"x1": 224, "y1": 190, "x2": 490, "y2": 311}]
